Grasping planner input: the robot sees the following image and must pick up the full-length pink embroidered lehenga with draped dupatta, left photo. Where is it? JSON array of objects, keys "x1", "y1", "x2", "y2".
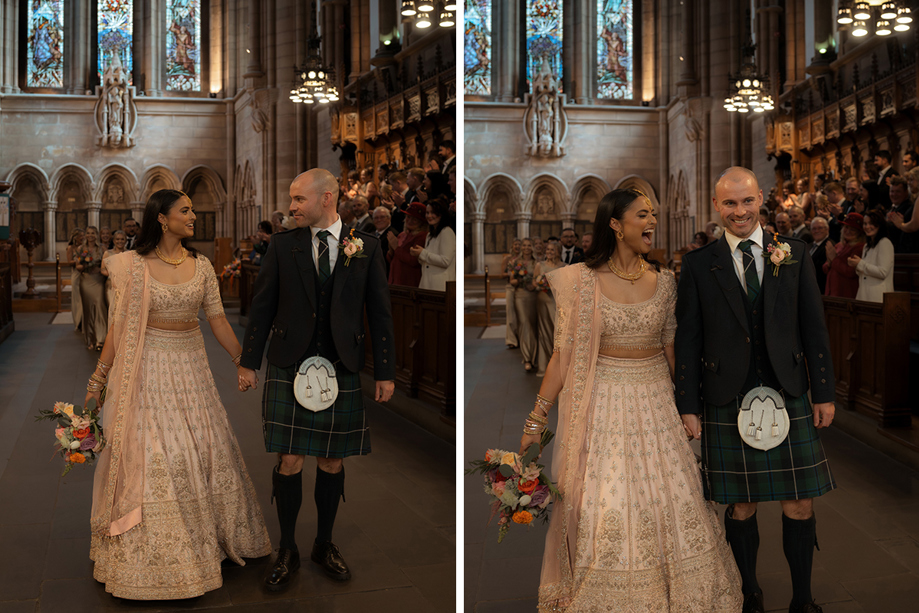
[{"x1": 90, "y1": 251, "x2": 271, "y2": 600}]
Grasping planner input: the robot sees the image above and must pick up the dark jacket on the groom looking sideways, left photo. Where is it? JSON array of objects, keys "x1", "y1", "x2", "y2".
[{"x1": 241, "y1": 228, "x2": 396, "y2": 381}]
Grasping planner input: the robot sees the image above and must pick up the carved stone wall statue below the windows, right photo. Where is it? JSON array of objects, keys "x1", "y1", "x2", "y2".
[{"x1": 523, "y1": 59, "x2": 568, "y2": 157}]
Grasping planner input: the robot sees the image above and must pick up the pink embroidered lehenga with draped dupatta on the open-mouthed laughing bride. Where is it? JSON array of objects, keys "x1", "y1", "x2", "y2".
[{"x1": 539, "y1": 264, "x2": 743, "y2": 613}]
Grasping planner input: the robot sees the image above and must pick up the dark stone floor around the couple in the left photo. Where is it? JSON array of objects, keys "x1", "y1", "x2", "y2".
[{"x1": 0, "y1": 313, "x2": 456, "y2": 613}]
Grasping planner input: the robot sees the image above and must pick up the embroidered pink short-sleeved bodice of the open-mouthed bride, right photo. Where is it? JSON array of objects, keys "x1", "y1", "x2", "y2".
[{"x1": 600, "y1": 270, "x2": 676, "y2": 351}]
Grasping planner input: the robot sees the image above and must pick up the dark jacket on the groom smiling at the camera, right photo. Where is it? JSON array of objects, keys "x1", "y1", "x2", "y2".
[{"x1": 675, "y1": 236, "x2": 835, "y2": 414}]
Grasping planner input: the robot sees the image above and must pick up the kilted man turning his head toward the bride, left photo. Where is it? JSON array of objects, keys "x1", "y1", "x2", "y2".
[{"x1": 239, "y1": 169, "x2": 395, "y2": 591}]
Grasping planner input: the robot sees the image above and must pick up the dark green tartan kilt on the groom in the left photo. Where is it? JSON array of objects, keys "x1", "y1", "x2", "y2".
[{"x1": 262, "y1": 361, "x2": 370, "y2": 458}]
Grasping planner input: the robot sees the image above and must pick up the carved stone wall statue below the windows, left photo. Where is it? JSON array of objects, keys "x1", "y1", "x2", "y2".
[{"x1": 95, "y1": 54, "x2": 137, "y2": 149}]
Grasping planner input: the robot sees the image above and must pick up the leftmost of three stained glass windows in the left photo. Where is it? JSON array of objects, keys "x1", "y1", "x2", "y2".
[{"x1": 26, "y1": 0, "x2": 64, "y2": 87}]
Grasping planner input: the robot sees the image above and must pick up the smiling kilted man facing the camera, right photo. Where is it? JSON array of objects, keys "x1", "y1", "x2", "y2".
[{"x1": 675, "y1": 167, "x2": 836, "y2": 613}]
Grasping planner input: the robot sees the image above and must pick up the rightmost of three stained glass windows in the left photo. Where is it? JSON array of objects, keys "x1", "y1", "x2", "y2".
[{"x1": 166, "y1": 0, "x2": 201, "y2": 92}]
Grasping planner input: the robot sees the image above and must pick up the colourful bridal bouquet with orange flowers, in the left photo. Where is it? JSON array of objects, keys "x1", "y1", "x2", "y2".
[{"x1": 35, "y1": 390, "x2": 105, "y2": 477}]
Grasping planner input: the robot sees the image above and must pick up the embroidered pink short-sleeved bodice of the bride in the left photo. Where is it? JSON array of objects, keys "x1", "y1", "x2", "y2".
[{"x1": 147, "y1": 254, "x2": 224, "y2": 324}]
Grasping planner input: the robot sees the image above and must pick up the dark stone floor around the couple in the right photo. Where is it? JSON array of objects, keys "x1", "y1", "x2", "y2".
[{"x1": 462, "y1": 328, "x2": 919, "y2": 613}]
